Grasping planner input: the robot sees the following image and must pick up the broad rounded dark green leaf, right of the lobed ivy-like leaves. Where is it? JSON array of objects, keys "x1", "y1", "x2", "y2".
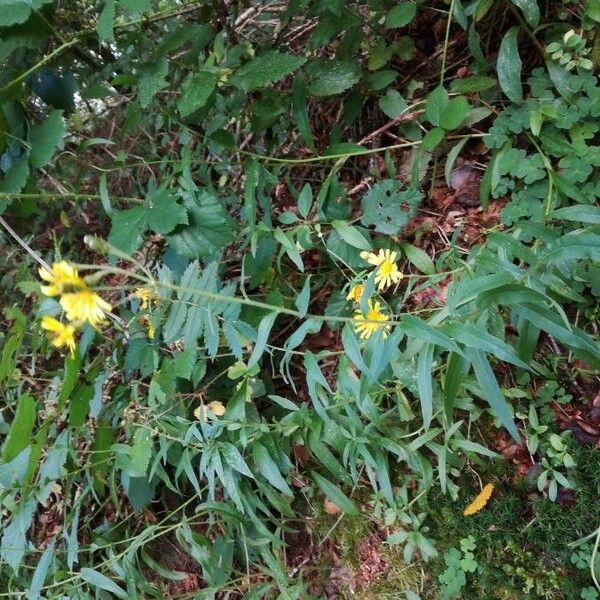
[{"x1": 167, "y1": 191, "x2": 234, "y2": 258}]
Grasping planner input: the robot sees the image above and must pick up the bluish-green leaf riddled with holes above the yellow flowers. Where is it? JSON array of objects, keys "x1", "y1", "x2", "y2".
[{"x1": 361, "y1": 179, "x2": 422, "y2": 235}]
